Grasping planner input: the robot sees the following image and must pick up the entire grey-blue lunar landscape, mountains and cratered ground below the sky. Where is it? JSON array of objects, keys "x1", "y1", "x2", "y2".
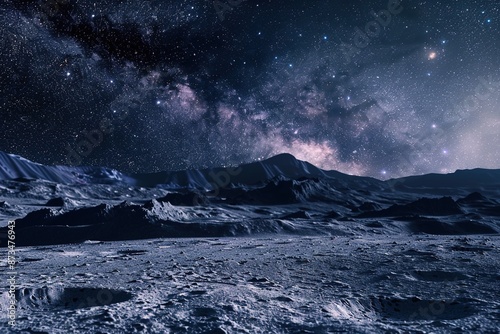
[{"x1": 0, "y1": 153, "x2": 500, "y2": 333}]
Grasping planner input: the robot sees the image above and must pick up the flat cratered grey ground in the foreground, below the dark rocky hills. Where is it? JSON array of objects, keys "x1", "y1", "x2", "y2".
[{"x1": 0, "y1": 235, "x2": 500, "y2": 333}]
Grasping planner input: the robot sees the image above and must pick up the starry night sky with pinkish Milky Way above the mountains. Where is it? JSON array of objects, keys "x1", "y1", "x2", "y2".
[{"x1": 0, "y1": 0, "x2": 500, "y2": 179}]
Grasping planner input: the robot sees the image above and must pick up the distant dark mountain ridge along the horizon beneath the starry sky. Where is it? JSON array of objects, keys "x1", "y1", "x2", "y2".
[{"x1": 0, "y1": 151, "x2": 500, "y2": 189}]
